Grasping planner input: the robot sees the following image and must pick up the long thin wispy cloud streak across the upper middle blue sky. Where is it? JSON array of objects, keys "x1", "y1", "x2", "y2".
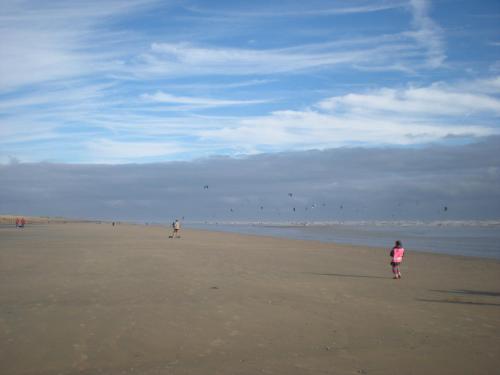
[{"x1": 133, "y1": 36, "x2": 430, "y2": 78}]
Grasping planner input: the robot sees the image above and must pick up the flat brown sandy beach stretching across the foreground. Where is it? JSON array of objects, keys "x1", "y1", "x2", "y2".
[{"x1": 0, "y1": 224, "x2": 500, "y2": 375}]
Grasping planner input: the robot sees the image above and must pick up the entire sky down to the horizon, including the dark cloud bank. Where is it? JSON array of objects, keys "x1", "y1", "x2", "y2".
[{"x1": 0, "y1": 0, "x2": 500, "y2": 220}]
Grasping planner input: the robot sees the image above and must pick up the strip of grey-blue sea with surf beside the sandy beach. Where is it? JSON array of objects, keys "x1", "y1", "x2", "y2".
[{"x1": 186, "y1": 222, "x2": 500, "y2": 259}]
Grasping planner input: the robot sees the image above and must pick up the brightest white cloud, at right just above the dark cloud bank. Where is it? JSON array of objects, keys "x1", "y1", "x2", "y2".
[{"x1": 198, "y1": 77, "x2": 500, "y2": 150}]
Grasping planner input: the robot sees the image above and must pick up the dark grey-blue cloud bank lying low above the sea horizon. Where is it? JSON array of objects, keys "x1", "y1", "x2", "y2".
[{"x1": 0, "y1": 137, "x2": 500, "y2": 222}]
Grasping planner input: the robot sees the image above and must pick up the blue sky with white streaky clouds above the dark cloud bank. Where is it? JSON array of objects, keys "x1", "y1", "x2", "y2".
[{"x1": 0, "y1": 0, "x2": 500, "y2": 164}]
